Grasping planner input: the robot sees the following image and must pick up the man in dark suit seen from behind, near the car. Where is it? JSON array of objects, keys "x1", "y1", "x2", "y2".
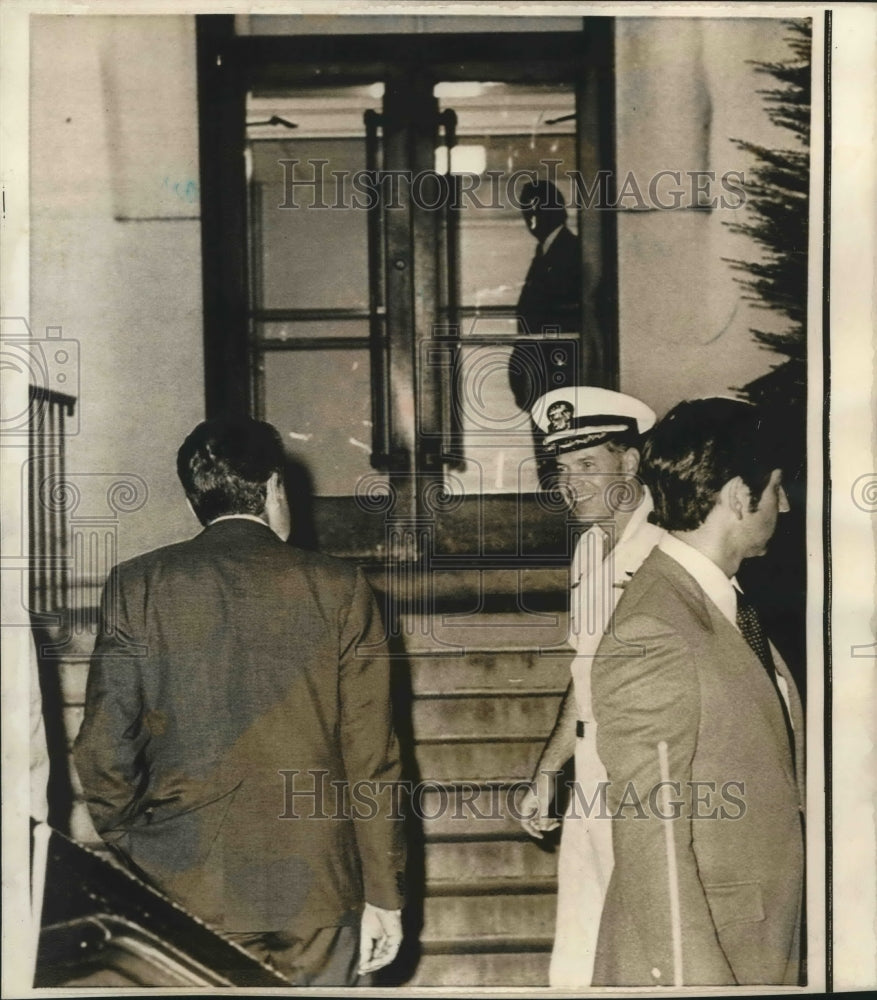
[{"x1": 75, "y1": 420, "x2": 404, "y2": 986}]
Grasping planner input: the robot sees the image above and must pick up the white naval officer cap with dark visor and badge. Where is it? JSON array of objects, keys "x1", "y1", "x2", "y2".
[{"x1": 531, "y1": 385, "x2": 657, "y2": 453}]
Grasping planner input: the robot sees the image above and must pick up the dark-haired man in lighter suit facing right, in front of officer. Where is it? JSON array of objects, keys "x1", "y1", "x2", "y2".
[{"x1": 592, "y1": 399, "x2": 804, "y2": 986}]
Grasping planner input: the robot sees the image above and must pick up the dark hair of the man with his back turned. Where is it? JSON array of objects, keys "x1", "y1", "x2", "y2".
[{"x1": 177, "y1": 417, "x2": 285, "y2": 524}]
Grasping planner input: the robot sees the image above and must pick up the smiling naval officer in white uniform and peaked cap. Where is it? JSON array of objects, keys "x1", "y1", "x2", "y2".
[{"x1": 521, "y1": 386, "x2": 664, "y2": 987}]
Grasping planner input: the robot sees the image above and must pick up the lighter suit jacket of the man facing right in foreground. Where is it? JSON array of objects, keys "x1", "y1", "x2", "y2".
[{"x1": 592, "y1": 550, "x2": 804, "y2": 986}]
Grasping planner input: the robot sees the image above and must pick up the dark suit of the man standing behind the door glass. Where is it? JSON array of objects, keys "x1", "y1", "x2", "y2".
[{"x1": 509, "y1": 226, "x2": 582, "y2": 410}]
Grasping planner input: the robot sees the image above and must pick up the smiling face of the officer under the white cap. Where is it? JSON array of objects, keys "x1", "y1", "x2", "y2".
[{"x1": 557, "y1": 444, "x2": 639, "y2": 521}]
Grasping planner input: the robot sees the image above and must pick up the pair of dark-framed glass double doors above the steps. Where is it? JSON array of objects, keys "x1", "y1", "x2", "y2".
[{"x1": 233, "y1": 54, "x2": 604, "y2": 561}]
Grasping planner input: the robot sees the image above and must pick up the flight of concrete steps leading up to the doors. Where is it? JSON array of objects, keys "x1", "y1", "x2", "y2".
[{"x1": 388, "y1": 568, "x2": 572, "y2": 988}]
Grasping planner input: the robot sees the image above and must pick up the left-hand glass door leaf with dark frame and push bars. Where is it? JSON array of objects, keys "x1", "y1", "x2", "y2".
[{"x1": 246, "y1": 79, "x2": 451, "y2": 558}]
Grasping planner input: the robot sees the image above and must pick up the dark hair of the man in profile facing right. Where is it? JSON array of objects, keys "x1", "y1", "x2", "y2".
[{"x1": 640, "y1": 398, "x2": 782, "y2": 531}]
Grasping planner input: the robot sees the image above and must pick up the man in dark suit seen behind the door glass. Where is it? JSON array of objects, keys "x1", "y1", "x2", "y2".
[{"x1": 509, "y1": 181, "x2": 582, "y2": 486}]
